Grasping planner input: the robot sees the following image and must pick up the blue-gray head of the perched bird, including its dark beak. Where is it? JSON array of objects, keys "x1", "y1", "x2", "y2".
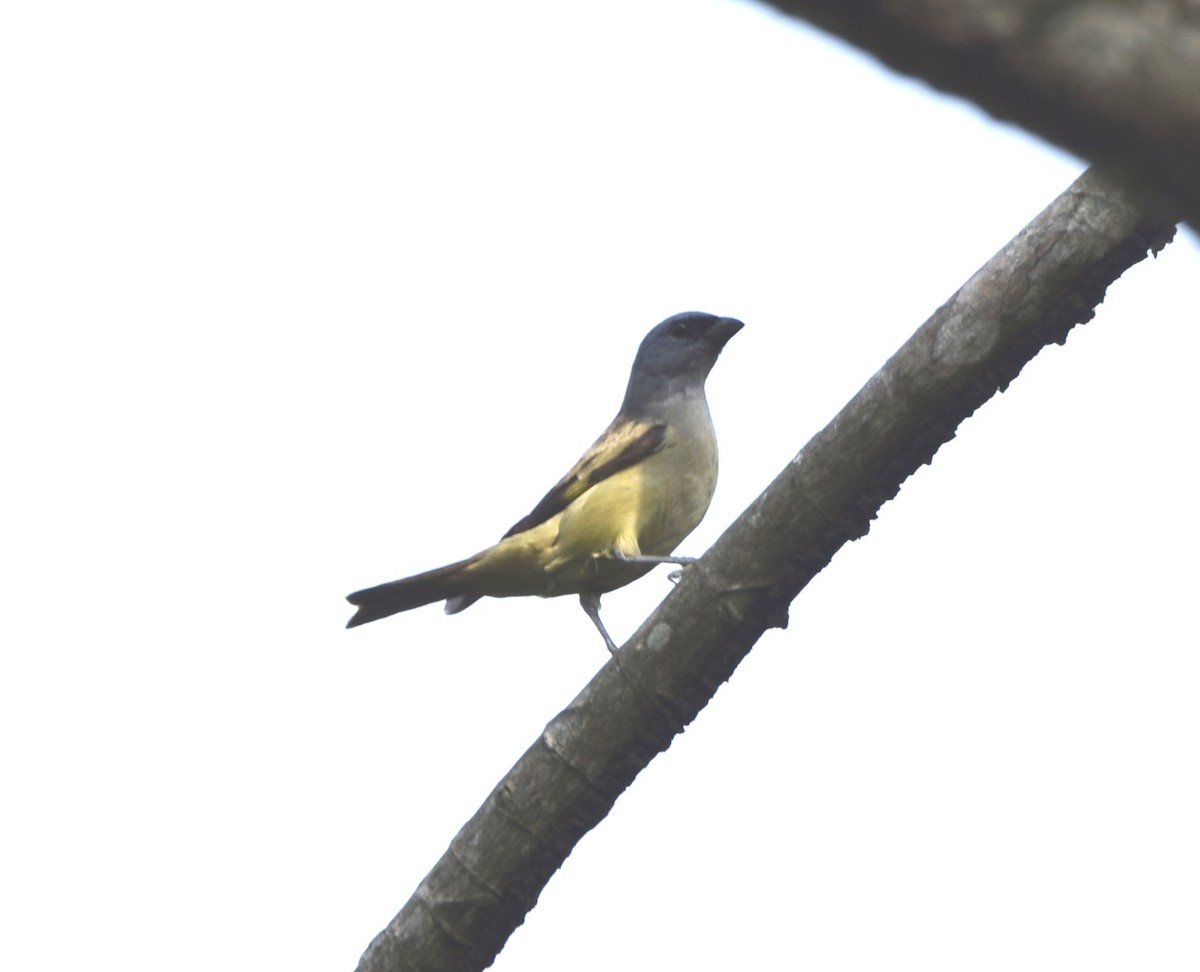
[{"x1": 622, "y1": 311, "x2": 743, "y2": 412}]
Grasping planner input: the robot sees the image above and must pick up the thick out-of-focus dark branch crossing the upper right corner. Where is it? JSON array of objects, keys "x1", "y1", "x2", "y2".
[{"x1": 768, "y1": 0, "x2": 1200, "y2": 229}]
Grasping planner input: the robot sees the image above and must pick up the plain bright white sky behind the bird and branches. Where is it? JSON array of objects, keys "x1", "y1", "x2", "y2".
[{"x1": 0, "y1": 0, "x2": 1200, "y2": 972}]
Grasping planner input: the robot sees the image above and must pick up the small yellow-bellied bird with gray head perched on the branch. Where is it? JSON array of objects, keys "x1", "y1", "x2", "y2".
[{"x1": 347, "y1": 311, "x2": 744, "y2": 654}]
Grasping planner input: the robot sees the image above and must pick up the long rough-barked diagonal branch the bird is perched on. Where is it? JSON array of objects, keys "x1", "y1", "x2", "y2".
[{"x1": 359, "y1": 172, "x2": 1174, "y2": 972}]
